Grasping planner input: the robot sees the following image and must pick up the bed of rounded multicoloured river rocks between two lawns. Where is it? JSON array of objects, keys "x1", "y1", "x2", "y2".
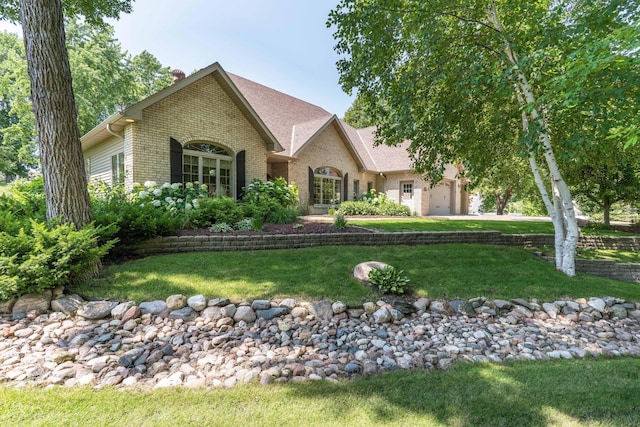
[{"x1": 0, "y1": 295, "x2": 640, "y2": 389}]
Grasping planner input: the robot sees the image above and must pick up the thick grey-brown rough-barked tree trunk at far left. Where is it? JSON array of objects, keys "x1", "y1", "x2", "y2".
[{"x1": 20, "y1": 0, "x2": 92, "y2": 228}]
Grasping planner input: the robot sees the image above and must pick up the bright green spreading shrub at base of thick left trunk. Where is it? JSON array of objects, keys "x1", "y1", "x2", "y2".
[{"x1": 0, "y1": 220, "x2": 113, "y2": 300}]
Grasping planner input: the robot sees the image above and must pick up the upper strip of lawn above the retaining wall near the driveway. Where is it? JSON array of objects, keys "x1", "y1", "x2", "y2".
[{"x1": 349, "y1": 218, "x2": 631, "y2": 236}]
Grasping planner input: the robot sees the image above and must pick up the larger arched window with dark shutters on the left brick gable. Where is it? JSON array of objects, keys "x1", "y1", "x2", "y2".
[{"x1": 182, "y1": 142, "x2": 233, "y2": 197}]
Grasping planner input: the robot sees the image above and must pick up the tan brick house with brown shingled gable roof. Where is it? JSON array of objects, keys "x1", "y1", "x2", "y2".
[{"x1": 81, "y1": 63, "x2": 468, "y2": 215}]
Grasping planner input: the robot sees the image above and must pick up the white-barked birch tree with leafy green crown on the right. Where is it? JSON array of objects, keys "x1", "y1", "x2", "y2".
[{"x1": 327, "y1": 0, "x2": 638, "y2": 275}]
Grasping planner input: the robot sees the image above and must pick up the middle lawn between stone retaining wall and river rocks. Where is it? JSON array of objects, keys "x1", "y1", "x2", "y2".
[{"x1": 74, "y1": 244, "x2": 640, "y2": 304}]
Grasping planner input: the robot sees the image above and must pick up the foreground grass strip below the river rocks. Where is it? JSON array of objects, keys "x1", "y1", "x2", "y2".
[{"x1": 0, "y1": 358, "x2": 640, "y2": 426}]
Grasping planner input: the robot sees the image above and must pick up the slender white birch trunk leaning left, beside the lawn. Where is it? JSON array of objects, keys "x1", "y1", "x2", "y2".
[{"x1": 487, "y1": 2, "x2": 579, "y2": 276}]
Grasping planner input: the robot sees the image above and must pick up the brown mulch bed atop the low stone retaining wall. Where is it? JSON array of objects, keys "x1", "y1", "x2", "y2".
[{"x1": 174, "y1": 221, "x2": 373, "y2": 236}]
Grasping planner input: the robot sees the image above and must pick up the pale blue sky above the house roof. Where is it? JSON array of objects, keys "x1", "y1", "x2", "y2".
[{"x1": 0, "y1": 0, "x2": 354, "y2": 117}]
